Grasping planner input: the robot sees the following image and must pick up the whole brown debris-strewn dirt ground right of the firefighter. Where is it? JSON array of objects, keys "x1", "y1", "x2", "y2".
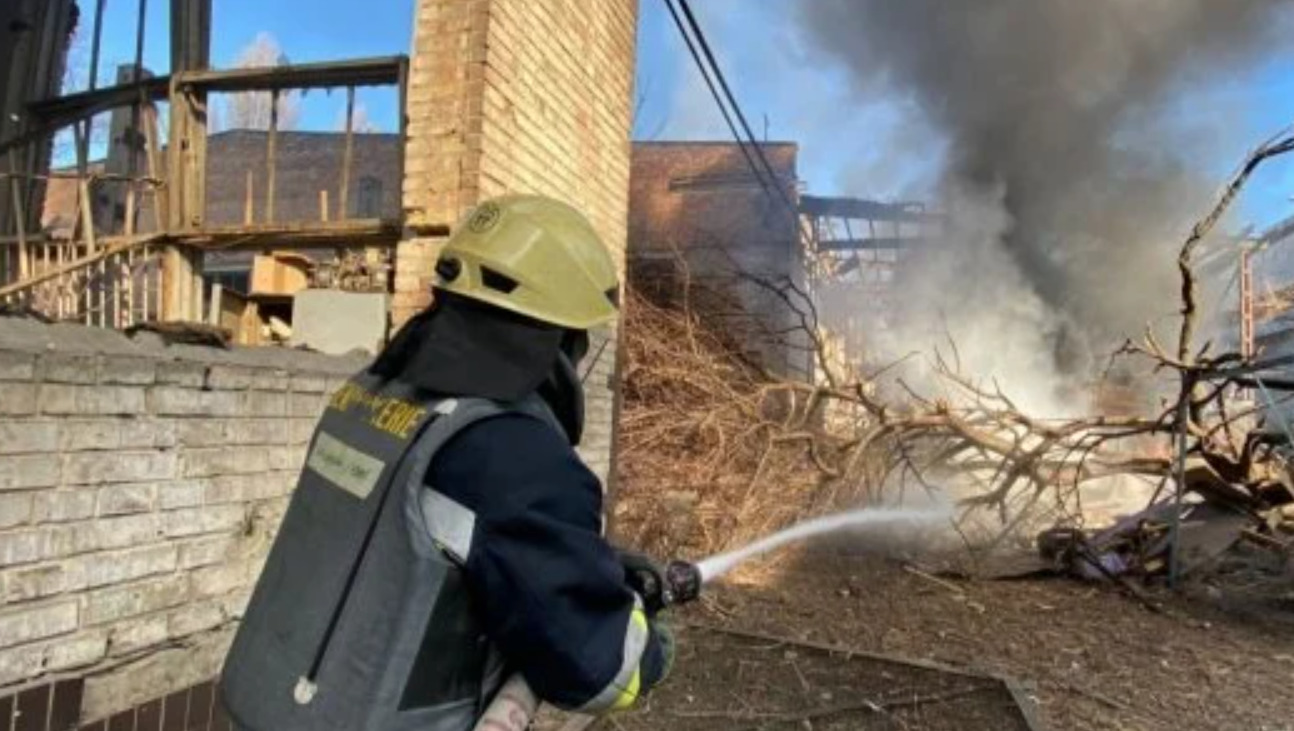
[{"x1": 582, "y1": 552, "x2": 1294, "y2": 731}]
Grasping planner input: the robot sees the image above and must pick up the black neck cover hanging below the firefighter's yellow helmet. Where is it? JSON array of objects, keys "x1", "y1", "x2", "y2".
[{"x1": 369, "y1": 290, "x2": 589, "y2": 445}]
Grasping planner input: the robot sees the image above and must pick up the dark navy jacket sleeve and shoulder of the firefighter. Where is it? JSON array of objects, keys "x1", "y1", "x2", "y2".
[{"x1": 426, "y1": 414, "x2": 665, "y2": 709}]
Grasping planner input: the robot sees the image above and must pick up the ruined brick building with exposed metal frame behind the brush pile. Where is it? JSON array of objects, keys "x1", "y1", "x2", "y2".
[{"x1": 629, "y1": 141, "x2": 945, "y2": 382}]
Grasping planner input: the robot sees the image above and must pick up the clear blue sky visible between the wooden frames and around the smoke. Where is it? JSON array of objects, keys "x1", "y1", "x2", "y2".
[{"x1": 87, "y1": 0, "x2": 1294, "y2": 228}]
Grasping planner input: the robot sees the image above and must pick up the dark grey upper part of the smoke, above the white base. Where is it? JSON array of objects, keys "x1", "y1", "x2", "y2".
[{"x1": 797, "y1": 0, "x2": 1294, "y2": 364}]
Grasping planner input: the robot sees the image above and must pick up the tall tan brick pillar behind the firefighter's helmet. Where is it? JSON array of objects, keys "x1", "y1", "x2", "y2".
[{"x1": 392, "y1": 0, "x2": 638, "y2": 476}]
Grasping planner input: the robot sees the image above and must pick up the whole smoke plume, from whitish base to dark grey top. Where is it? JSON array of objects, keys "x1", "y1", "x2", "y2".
[{"x1": 796, "y1": 0, "x2": 1294, "y2": 415}]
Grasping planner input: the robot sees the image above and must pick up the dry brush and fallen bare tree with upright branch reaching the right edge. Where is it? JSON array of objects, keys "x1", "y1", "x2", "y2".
[{"x1": 616, "y1": 128, "x2": 1294, "y2": 566}]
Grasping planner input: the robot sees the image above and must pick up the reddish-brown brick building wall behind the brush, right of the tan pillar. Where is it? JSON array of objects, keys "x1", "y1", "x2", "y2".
[{"x1": 629, "y1": 142, "x2": 813, "y2": 379}]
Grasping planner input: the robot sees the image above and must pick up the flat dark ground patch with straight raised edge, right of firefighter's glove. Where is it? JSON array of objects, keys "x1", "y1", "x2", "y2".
[{"x1": 592, "y1": 625, "x2": 1030, "y2": 731}]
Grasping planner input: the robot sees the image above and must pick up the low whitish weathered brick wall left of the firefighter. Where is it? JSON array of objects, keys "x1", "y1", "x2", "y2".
[{"x1": 0, "y1": 318, "x2": 362, "y2": 728}]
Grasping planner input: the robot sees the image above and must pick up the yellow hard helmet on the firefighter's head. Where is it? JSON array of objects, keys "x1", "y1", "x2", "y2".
[{"x1": 435, "y1": 195, "x2": 620, "y2": 330}]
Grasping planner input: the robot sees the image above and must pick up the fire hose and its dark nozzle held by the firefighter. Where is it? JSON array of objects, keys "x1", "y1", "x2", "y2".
[{"x1": 474, "y1": 551, "x2": 701, "y2": 731}]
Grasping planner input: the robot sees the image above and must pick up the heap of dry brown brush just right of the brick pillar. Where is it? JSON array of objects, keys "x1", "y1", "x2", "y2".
[{"x1": 615, "y1": 288, "x2": 843, "y2": 555}]
